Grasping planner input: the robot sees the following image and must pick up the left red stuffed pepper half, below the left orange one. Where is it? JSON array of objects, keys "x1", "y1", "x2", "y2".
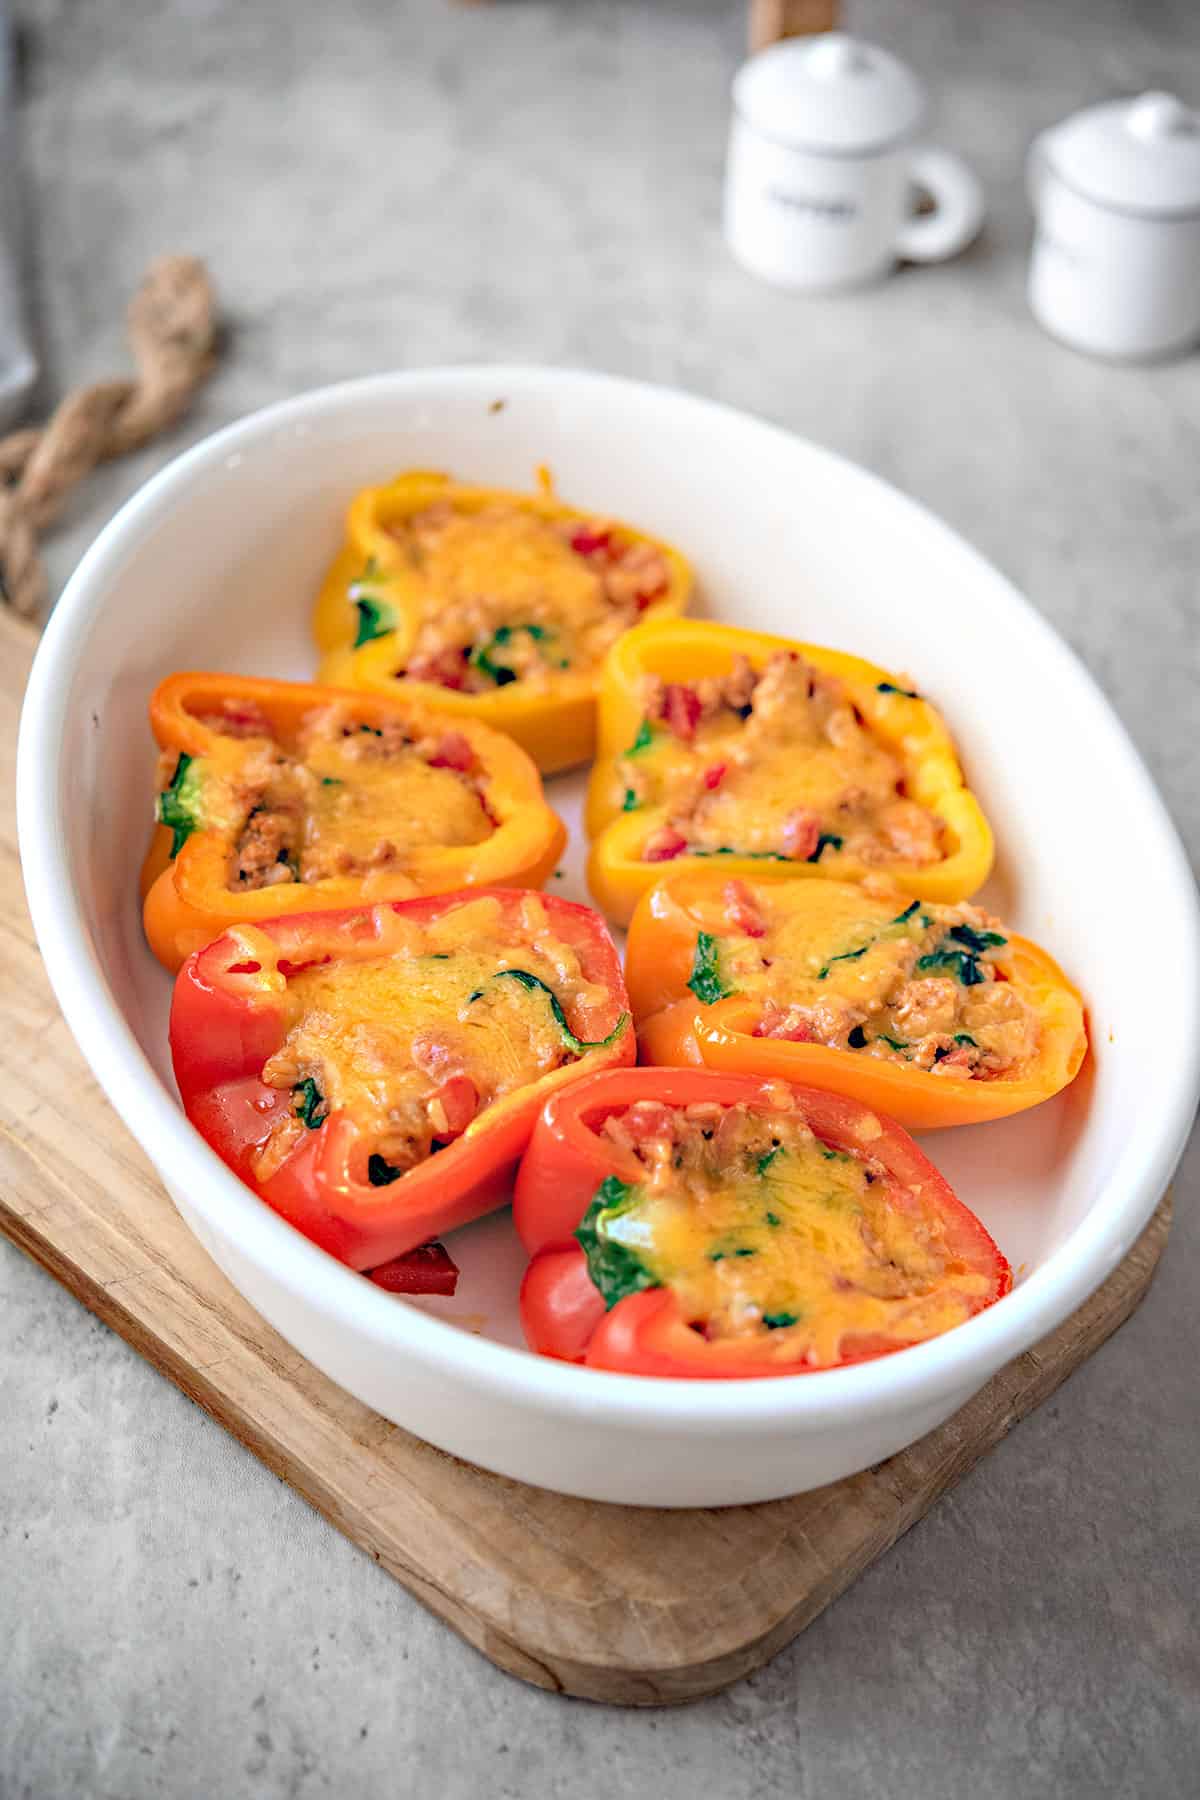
[{"x1": 171, "y1": 889, "x2": 635, "y2": 1267}]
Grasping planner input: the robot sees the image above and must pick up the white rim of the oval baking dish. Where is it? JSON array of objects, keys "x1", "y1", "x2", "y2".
[{"x1": 16, "y1": 364, "x2": 1200, "y2": 1436}]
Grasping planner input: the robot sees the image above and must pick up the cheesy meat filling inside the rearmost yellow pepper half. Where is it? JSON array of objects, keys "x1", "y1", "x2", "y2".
[{"x1": 379, "y1": 500, "x2": 671, "y2": 693}]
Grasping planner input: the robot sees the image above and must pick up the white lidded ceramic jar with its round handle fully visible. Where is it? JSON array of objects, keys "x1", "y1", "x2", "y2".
[{"x1": 725, "y1": 32, "x2": 982, "y2": 288}]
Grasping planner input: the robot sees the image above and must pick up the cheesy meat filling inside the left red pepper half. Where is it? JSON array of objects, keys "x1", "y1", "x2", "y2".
[{"x1": 255, "y1": 895, "x2": 612, "y2": 1186}]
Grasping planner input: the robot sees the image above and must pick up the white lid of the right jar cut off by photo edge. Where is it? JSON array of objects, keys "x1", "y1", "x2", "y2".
[{"x1": 1040, "y1": 92, "x2": 1200, "y2": 216}]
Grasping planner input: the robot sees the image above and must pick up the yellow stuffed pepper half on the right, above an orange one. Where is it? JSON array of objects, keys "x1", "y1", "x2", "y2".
[{"x1": 587, "y1": 619, "x2": 993, "y2": 923}]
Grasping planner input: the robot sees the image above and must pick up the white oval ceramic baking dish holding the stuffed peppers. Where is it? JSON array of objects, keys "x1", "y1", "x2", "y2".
[{"x1": 18, "y1": 367, "x2": 1200, "y2": 1507}]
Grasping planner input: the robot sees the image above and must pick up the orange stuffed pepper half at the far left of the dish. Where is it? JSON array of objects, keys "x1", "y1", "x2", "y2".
[{"x1": 142, "y1": 673, "x2": 567, "y2": 970}]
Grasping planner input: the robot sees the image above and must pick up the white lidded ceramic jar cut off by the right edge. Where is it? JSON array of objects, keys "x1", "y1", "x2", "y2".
[{"x1": 1029, "y1": 94, "x2": 1200, "y2": 358}]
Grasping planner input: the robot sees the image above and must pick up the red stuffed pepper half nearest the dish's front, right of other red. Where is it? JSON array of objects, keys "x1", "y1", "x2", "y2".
[{"x1": 513, "y1": 1069, "x2": 1013, "y2": 1377}]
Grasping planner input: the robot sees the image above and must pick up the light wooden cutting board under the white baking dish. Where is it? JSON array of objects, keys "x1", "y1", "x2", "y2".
[{"x1": 0, "y1": 616, "x2": 1171, "y2": 1706}]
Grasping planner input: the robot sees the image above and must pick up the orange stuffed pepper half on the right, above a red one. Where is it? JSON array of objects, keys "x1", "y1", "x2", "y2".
[{"x1": 626, "y1": 869, "x2": 1087, "y2": 1130}]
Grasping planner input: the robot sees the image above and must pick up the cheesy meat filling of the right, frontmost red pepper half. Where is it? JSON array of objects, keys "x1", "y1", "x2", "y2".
[{"x1": 579, "y1": 1084, "x2": 986, "y2": 1366}]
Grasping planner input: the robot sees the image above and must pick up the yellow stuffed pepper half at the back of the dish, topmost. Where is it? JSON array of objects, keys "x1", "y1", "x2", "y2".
[{"x1": 313, "y1": 470, "x2": 691, "y2": 774}]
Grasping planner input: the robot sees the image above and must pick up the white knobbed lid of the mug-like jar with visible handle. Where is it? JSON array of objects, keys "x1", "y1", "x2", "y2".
[{"x1": 734, "y1": 31, "x2": 925, "y2": 153}]
